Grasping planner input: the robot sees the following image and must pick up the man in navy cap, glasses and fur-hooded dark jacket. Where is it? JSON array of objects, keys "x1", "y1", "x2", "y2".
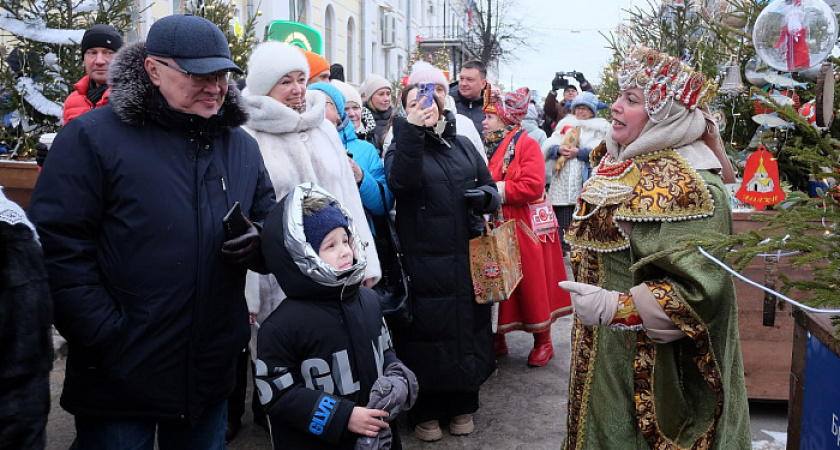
[{"x1": 30, "y1": 15, "x2": 275, "y2": 450}]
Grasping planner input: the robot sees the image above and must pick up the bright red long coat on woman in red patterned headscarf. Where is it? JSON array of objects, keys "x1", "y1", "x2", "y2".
[{"x1": 488, "y1": 127, "x2": 572, "y2": 333}]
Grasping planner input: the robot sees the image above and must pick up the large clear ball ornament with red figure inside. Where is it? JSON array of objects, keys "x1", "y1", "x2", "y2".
[{"x1": 753, "y1": 0, "x2": 837, "y2": 72}]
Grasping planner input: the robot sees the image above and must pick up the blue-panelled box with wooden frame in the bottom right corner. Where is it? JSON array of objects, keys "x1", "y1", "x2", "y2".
[{"x1": 786, "y1": 308, "x2": 840, "y2": 450}]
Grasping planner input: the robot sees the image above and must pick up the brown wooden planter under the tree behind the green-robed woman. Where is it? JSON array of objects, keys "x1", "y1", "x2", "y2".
[{"x1": 732, "y1": 211, "x2": 811, "y2": 401}]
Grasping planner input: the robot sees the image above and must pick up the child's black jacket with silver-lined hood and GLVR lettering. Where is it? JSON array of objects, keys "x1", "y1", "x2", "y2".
[{"x1": 256, "y1": 183, "x2": 399, "y2": 450}]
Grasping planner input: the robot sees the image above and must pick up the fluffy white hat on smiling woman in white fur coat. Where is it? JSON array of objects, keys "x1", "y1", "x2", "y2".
[{"x1": 245, "y1": 41, "x2": 309, "y2": 95}]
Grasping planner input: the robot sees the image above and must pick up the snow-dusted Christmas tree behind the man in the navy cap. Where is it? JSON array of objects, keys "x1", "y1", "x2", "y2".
[{"x1": 0, "y1": 0, "x2": 134, "y2": 158}]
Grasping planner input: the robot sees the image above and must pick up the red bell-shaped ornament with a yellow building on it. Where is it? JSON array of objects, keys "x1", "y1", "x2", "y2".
[{"x1": 735, "y1": 145, "x2": 785, "y2": 210}]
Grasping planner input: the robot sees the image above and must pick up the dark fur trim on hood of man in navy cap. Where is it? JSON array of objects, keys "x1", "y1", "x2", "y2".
[{"x1": 108, "y1": 41, "x2": 248, "y2": 128}]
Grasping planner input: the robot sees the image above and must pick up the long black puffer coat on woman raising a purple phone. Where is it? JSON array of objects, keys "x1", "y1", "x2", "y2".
[{"x1": 385, "y1": 113, "x2": 499, "y2": 396}]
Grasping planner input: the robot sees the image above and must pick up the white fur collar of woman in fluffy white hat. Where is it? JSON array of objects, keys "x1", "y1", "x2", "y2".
[{"x1": 242, "y1": 87, "x2": 327, "y2": 134}]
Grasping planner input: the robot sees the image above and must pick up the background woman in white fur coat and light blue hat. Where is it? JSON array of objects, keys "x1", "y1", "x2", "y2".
[{"x1": 542, "y1": 92, "x2": 610, "y2": 254}]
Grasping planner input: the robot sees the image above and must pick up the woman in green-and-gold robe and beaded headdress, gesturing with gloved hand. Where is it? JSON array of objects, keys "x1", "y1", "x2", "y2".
[{"x1": 560, "y1": 48, "x2": 751, "y2": 450}]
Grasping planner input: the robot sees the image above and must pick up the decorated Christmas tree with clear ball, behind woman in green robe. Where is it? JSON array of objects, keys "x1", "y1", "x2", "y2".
[{"x1": 599, "y1": 0, "x2": 840, "y2": 318}]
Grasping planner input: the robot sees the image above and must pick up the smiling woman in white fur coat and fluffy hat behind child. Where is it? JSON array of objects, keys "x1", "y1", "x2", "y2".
[{"x1": 242, "y1": 42, "x2": 381, "y2": 326}]
